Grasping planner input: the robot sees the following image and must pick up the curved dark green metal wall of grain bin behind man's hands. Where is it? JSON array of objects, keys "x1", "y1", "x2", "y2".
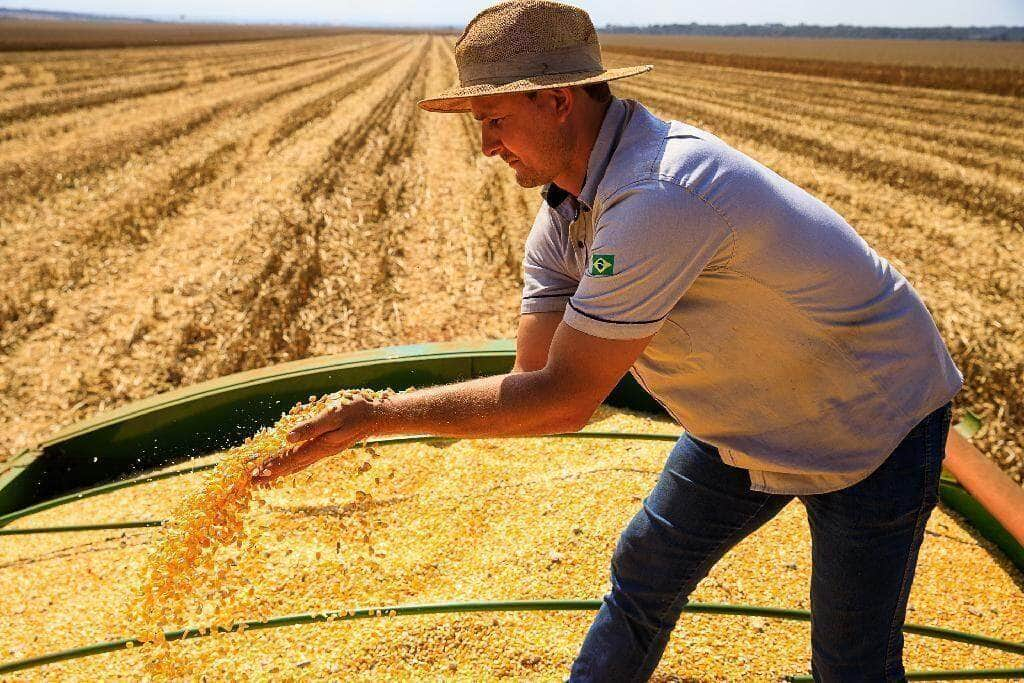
[{"x1": 0, "y1": 339, "x2": 660, "y2": 515}]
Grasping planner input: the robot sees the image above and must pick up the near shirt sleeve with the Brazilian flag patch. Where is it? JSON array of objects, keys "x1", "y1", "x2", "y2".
[{"x1": 562, "y1": 179, "x2": 733, "y2": 339}]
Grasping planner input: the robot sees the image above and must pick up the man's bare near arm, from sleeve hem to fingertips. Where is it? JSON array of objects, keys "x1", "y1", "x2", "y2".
[{"x1": 257, "y1": 318, "x2": 650, "y2": 483}]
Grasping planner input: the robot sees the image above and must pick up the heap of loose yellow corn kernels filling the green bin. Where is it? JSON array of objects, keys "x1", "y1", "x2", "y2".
[{"x1": 0, "y1": 407, "x2": 1024, "y2": 682}]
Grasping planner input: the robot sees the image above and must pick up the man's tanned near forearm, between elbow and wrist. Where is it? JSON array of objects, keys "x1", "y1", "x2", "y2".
[{"x1": 373, "y1": 370, "x2": 590, "y2": 437}]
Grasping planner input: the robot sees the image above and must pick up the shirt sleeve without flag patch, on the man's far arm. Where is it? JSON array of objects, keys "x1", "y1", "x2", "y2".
[{"x1": 519, "y1": 204, "x2": 579, "y2": 313}]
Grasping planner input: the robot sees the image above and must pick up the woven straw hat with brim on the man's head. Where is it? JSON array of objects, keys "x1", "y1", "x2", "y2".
[{"x1": 420, "y1": 0, "x2": 651, "y2": 112}]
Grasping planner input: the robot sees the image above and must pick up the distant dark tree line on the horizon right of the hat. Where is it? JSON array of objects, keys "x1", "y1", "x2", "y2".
[{"x1": 603, "y1": 24, "x2": 1024, "y2": 41}]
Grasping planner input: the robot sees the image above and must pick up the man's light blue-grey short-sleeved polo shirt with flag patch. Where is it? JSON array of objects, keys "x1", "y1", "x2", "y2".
[{"x1": 521, "y1": 99, "x2": 964, "y2": 495}]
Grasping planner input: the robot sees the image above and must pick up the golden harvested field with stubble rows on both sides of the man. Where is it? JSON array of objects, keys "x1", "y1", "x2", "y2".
[{"x1": 0, "y1": 28, "x2": 1024, "y2": 501}]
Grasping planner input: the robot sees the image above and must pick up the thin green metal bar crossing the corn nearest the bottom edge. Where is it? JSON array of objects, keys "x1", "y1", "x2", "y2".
[{"x1": 0, "y1": 600, "x2": 1024, "y2": 680}]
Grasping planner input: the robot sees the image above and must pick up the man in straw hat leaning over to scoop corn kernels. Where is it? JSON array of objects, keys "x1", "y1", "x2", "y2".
[{"x1": 256, "y1": 0, "x2": 963, "y2": 681}]
